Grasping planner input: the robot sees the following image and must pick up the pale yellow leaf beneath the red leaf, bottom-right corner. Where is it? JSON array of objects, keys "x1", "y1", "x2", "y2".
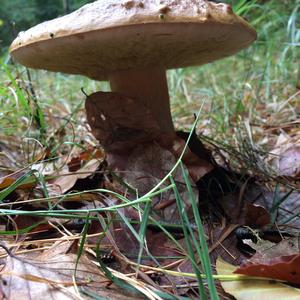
[{"x1": 216, "y1": 258, "x2": 300, "y2": 300}]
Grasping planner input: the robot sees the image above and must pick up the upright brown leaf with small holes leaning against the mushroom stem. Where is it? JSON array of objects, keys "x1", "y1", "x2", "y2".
[{"x1": 85, "y1": 92, "x2": 160, "y2": 154}]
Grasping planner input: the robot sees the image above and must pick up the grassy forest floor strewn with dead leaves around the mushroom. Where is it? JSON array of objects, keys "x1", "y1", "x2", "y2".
[{"x1": 0, "y1": 0, "x2": 300, "y2": 299}]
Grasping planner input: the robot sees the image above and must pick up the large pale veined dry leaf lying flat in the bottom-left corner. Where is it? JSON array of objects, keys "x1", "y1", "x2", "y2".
[{"x1": 0, "y1": 247, "x2": 140, "y2": 300}]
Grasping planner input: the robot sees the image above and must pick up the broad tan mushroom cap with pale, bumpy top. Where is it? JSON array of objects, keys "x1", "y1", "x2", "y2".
[{"x1": 10, "y1": 0, "x2": 256, "y2": 80}]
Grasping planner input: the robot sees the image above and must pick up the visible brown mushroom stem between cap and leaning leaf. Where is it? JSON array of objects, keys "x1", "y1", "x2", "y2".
[{"x1": 109, "y1": 67, "x2": 174, "y2": 133}]
